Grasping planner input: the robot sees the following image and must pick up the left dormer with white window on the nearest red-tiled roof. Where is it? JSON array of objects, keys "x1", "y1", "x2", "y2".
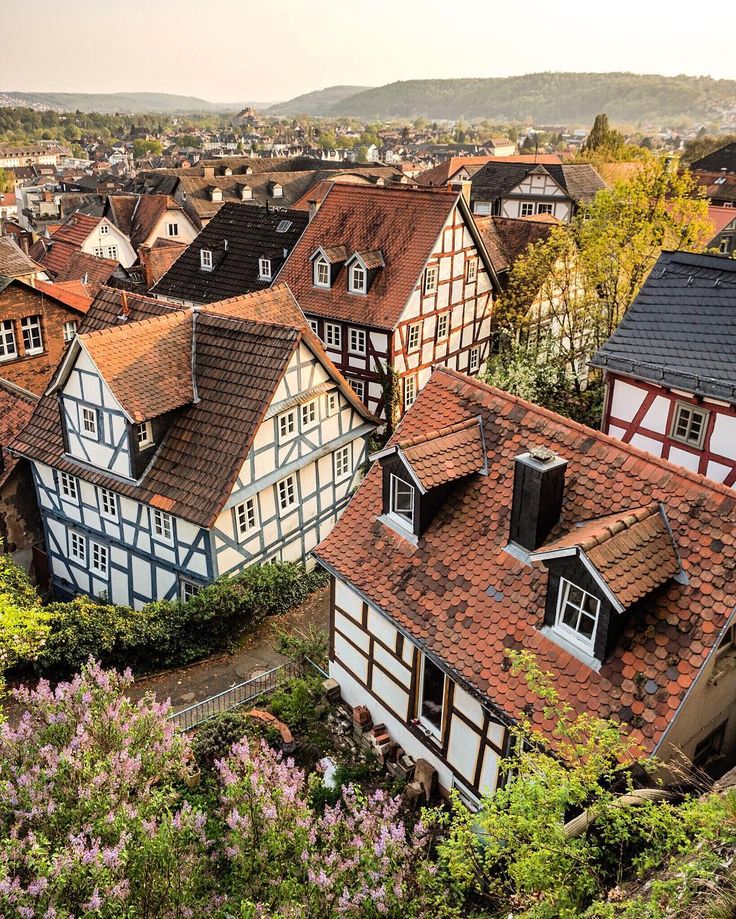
[{"x1": 371, "y1": 416, "x2": 488, "y2": 541}]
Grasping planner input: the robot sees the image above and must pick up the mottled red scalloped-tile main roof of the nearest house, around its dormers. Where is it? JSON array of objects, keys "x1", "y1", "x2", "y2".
[{"x1": 315, "y1": 368, "x2": 736, "y2": 753}]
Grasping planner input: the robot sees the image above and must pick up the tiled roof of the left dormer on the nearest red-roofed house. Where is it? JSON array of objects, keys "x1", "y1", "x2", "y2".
[{"x1": 397, "y1": 418, "x2": 486, "y2": 491}]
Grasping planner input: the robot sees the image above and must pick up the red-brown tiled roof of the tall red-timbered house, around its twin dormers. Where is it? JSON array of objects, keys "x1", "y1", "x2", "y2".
[{"x1": 279, "y1": 183, "x2": 459, "y2": 329}]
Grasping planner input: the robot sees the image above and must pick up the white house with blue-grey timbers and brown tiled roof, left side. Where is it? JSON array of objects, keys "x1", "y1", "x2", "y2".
[{"x1": 13, "y1": 286, "x2": 375, "y2": 607}]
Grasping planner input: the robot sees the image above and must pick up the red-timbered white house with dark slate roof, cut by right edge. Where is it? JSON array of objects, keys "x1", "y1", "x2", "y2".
[{"x1": 591, "y1": 252, "x2": 736, "y2": 486}]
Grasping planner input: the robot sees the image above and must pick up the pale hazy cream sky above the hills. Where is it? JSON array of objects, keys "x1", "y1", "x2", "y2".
[{"x1": 0, "y1": 0, "x2": 736, "y2": 102}]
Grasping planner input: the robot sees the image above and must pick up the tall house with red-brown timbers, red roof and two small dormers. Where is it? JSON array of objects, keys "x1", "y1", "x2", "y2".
[{"x1": 280, "y1": 183, "x2": 500, "y2": 415}]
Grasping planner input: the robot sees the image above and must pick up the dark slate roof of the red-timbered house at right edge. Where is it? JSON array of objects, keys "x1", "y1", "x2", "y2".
[{"x1": 591, "y1": 252, "x2": 736, "y2": 402}]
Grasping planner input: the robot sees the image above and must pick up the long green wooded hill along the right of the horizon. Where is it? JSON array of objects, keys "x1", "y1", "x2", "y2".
[{"x1": 326, "y1": 73, "x2": 736, "y2": 124}]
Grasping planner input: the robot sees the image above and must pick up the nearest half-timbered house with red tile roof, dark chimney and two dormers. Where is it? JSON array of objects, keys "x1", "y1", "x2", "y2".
[{"x1": 316, "y1": 368, "x2": 736, "y2": 803}]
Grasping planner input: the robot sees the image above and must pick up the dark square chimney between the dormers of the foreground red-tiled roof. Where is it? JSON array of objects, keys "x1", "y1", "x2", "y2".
[{"x1": 509, "y1": 447, "x2": 567, "y2": 552}]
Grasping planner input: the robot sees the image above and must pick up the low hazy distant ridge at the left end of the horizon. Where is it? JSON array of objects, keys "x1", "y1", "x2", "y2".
[{"x1": 0, "y1": 92, "x2": 253, "y2": 114}]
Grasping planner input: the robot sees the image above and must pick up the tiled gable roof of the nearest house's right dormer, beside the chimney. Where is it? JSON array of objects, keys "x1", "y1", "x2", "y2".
[{"x1": 533, "y1": 504, "x2": 680, "y2": 607}]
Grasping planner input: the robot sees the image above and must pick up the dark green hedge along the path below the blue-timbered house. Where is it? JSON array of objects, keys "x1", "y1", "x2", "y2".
[{"x1": 0, "y1": 562, "x2": 327, "y2": 679}]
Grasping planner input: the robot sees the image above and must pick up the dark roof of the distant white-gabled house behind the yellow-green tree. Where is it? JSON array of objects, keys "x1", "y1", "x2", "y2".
[{"x1": 470, "y1": 161, "x2": 606, "y2": 204}]
